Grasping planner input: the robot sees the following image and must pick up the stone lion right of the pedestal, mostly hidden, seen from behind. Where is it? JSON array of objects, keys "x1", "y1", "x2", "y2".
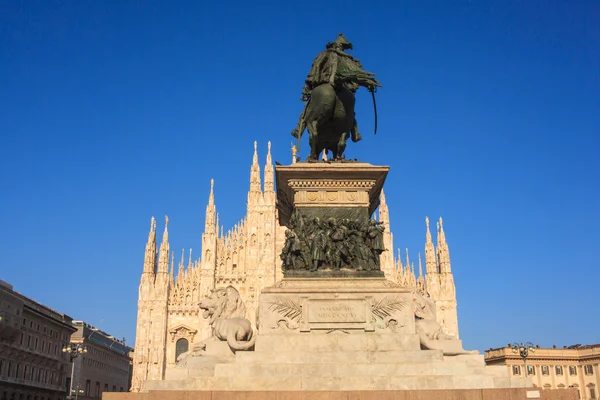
[{"x1": 413, "y1": 292, "x2": 479, "y2": 356}]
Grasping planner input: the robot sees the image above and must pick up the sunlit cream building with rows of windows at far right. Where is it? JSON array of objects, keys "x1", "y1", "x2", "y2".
[{"x1": 485, "y1": 344, "x2": 600, "y2": 400}]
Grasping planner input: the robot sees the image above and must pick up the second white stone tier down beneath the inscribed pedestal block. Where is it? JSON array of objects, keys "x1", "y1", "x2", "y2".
[{"x1": 235, "y1": 350, "x2": 443, "y2": 364}]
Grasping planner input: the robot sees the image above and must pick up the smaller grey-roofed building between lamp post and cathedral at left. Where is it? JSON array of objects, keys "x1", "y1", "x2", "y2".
[{"x1": 71, "y1": 321, "x2": 133, "y2": 400}]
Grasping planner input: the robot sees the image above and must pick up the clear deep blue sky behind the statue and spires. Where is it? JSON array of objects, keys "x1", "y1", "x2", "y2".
[{"x1": 0, "y1": 0, "x2": 600, "y2": 350}]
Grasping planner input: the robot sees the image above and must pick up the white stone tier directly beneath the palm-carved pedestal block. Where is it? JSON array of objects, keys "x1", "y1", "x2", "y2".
[{"x1": 255, "y1": 332, "x2": 421, "y2": 353}]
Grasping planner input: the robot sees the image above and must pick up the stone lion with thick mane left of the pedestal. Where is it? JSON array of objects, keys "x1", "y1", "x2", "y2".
[{"x1": 200, "y1": 286, "x2": 256, "y2": 350}]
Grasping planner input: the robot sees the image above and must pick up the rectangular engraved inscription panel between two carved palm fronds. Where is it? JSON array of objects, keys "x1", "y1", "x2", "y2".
[{"x1": 308, "y1": 300, "x2": 367, "y2": 323}]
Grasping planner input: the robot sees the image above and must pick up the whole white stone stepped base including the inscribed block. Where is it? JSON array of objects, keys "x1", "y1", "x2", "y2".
[{"x1": 132, "y1": 278, "x2": 532, "y2": 390}]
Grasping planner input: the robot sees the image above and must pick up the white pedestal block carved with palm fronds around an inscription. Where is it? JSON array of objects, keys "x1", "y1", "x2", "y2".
[{"x1": 258, "y1": 278, "x2": 419, "y2": 334}]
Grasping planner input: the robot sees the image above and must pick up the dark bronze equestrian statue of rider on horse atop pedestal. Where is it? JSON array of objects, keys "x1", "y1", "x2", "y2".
[{"x1": 292, "y1": 33, "x2": 381, "y2": 162}]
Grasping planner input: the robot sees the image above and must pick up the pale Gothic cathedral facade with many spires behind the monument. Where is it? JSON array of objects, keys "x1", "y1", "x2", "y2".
[{"x1": 132, "y1": 142, "x2": 458, "y2": 391}]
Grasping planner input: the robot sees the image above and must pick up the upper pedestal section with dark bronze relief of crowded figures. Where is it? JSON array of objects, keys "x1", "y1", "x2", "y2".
[{"x1": 276, "y1": 162, "x2": 389, "y2": 278}]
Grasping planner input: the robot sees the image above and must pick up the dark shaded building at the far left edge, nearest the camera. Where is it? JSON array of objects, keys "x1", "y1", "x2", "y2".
[{"x1": 0, "y1": 281, "x2": 76, "y2": 400}]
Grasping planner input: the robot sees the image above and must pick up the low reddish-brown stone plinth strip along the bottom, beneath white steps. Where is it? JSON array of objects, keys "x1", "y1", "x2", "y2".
[{"x1": 102, "y1": 388, "x2": 578, "y2": 400}]
